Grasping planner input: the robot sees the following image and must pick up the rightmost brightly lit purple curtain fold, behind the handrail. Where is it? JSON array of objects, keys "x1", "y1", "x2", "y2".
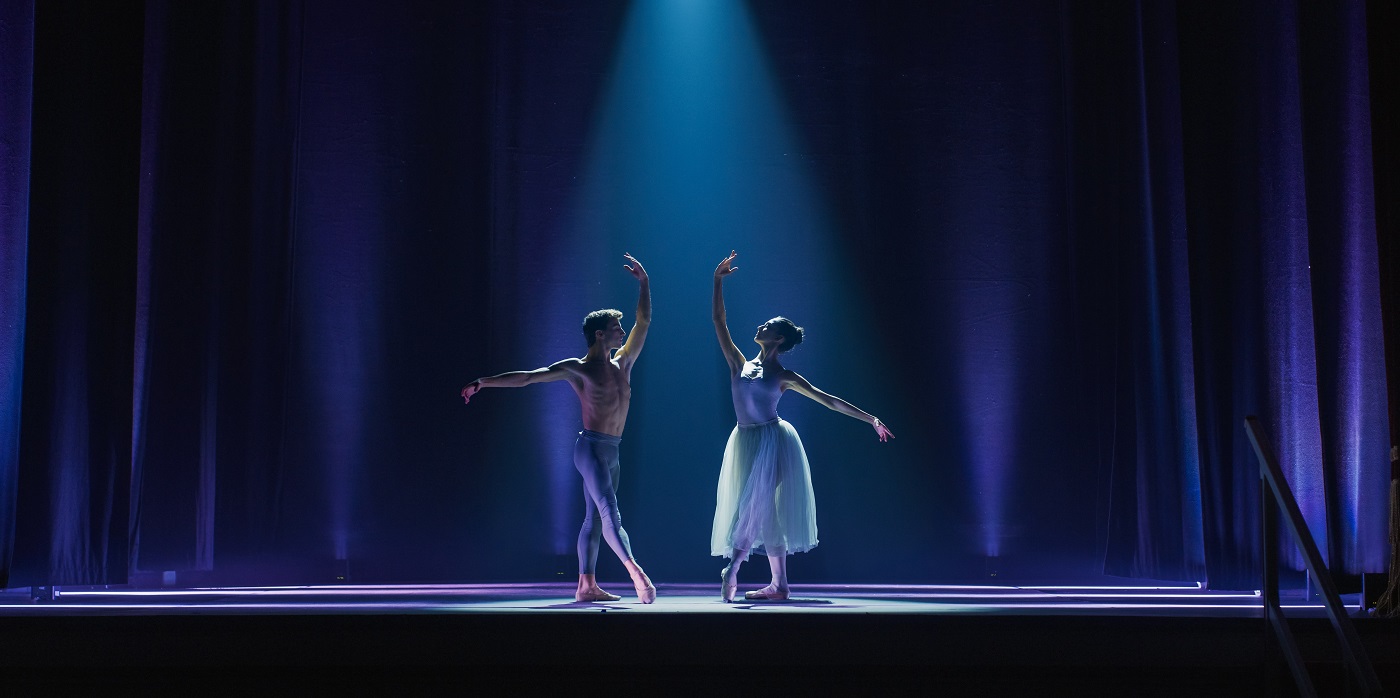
[{"x1": 1298, "y1": 3, "x2": 1394, "y2": 574}]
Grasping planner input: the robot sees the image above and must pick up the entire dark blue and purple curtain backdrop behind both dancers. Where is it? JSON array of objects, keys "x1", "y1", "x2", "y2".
[{"x1": 0, "y1": 0, "x2": 1397, "y2": 589}]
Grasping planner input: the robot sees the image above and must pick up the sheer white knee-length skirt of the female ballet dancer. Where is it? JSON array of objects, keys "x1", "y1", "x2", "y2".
[{"x1": 710, "y1": 420, "x2": 816, "y2": 557}]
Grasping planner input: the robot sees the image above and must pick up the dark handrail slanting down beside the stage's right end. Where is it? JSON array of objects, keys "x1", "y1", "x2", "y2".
[{"x1": 1245, "y1": 417, "x2": 1382, "y2": 697}]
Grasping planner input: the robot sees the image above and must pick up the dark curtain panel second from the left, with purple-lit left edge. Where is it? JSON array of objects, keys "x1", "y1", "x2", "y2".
[{"x1": 130, "y1": 3, "x2": 302, "y2": 576}]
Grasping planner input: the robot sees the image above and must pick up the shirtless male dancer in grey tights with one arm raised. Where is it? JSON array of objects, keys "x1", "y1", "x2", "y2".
[{"x1": 462, "y1": 255, "x2": 657, "y2": 603}]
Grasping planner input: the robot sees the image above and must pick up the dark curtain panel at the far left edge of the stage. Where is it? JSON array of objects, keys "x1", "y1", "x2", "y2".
[{"x1": 0, "y1": 3, "x2": 140, "y2": 585}]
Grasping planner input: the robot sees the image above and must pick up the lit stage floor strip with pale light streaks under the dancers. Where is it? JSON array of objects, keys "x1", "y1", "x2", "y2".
[{"x1": 0, "y1": 583, "x2": 1358, "y2": 618}]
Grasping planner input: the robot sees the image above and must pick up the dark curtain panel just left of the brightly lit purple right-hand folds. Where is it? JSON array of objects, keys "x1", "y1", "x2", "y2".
[{"x1": 1070, "y1": 3, "x2": 1205, "y2": 581}]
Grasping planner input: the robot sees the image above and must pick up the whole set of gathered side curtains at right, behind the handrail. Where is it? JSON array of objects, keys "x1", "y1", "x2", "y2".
[{"x1": 1070, "y1": 3, "x2": 1389, "y2": 587}]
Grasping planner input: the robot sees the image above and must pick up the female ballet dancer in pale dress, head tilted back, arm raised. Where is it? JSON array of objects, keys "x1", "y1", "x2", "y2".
[{"x1": 710, "y1": 250, "x2": 895, "y2": 603}]
